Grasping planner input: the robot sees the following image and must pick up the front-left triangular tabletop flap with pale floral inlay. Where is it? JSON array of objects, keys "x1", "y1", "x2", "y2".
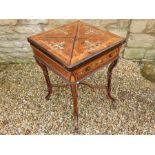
[{"x1": 36, "y1": 38, "x2": 74, "y2": 65}]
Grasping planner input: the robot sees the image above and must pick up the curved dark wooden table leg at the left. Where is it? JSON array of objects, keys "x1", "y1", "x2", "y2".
[{"x1": 35, "y1": 58, "x2": 52, "y2": 100}]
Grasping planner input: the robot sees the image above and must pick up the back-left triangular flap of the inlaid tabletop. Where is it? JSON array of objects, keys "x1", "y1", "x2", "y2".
[{"x1": 33, "y1": 22, "x2": 78, "y2": 39}]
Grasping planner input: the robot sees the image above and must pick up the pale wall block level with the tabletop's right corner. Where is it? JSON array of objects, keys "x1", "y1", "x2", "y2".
[{"x1": 127, "y1": 34, "x2": 155, "y2": 47}]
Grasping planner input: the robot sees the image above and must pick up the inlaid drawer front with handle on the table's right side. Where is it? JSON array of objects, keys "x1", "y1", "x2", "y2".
[{"x1": 76, "y1": 48, "x2": 119, "y2": 80}]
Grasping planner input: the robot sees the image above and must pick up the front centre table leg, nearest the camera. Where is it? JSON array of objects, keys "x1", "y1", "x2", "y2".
[{"x1": 70, "y1": 84, "x2": 78, "y2": 130}]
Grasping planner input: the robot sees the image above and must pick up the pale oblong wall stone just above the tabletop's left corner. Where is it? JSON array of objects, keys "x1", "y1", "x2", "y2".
[{"x1": 15, "y1": 25, "x2": 42, "y2": 34}]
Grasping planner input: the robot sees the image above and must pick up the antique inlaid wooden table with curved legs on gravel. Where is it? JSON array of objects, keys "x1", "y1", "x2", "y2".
[{"x1": 28, "y1": 21, "x2": 125, "y2": 129}]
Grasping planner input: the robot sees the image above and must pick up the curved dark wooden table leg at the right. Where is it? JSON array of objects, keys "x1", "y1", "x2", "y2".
[{"x1": 107, "y1": 59, "x2": 118, "y2": 101}]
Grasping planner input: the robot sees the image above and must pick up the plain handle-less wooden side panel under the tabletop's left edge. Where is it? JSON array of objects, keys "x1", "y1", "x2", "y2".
[{"x1": 31, "y1": 45, "x2": 71, "y2": 81}]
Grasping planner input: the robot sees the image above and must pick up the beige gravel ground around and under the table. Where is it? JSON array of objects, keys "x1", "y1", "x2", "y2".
[{"x1": 0, "y1": 59, "x2": 155, "y2": 135}]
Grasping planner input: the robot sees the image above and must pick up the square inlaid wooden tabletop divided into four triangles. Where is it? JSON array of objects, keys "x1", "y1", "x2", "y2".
[{"x1": 28, "y1": 21, "x2": 125, "y2": 70}]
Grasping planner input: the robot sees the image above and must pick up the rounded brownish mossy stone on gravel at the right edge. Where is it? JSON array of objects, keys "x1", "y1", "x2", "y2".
[{"x1": 141, "y1": 62, "x2": 155, "y2": 82}]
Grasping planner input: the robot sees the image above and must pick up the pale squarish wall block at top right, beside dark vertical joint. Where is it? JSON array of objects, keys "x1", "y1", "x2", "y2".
[{"x1": 130, "y1": 19, "x2": 147, "y2": 33}]
